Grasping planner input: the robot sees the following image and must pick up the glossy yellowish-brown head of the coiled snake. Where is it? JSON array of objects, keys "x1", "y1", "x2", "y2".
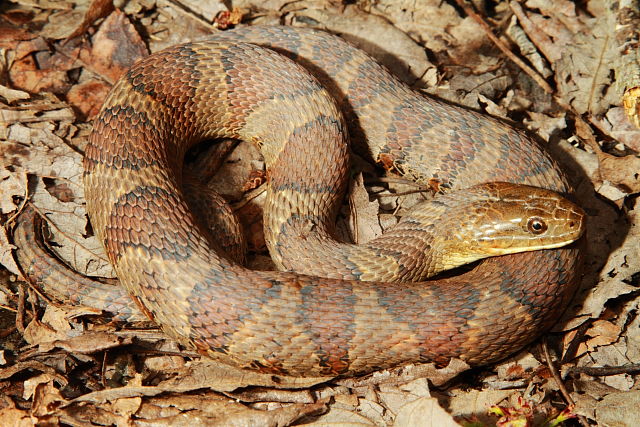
[{"x1": 441, "y1": 182, "x2": 586, "y2": 268}]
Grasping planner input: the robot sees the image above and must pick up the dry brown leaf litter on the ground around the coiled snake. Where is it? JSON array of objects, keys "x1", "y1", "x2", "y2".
[{"x1": 0, "y1": 0, "x2": 640, "y2": 426}]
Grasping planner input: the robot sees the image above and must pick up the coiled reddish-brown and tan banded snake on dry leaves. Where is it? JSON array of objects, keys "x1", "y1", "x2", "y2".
[{"x1": 16, "y1": 26, "x2": 585, "y2": 376}]
